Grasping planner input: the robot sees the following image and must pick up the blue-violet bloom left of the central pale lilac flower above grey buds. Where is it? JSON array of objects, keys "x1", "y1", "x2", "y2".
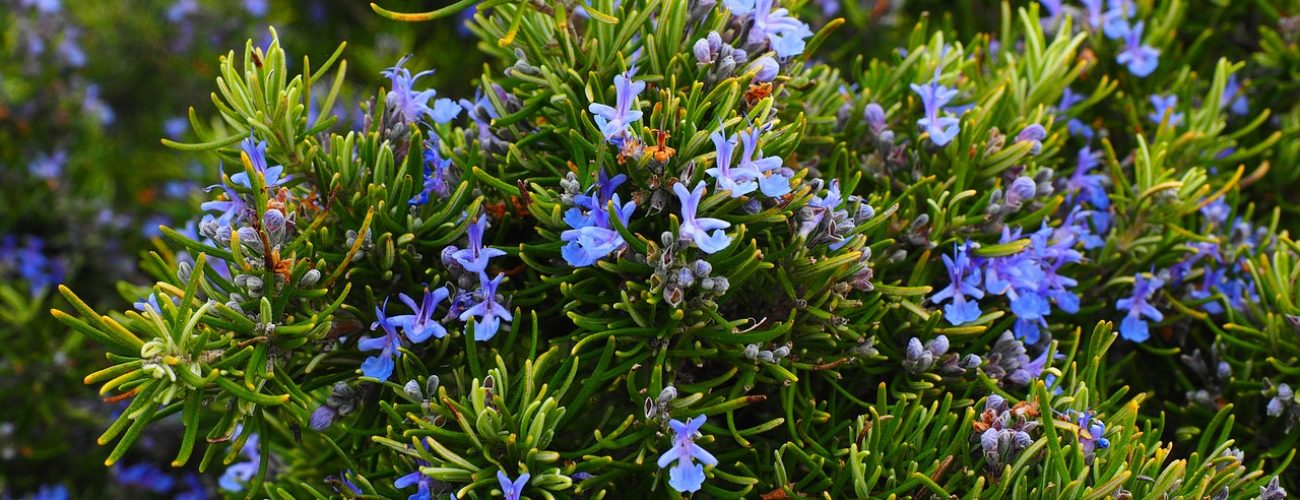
[{"x1": 560, "y1": 169, "x2": 637, "y2": 268}]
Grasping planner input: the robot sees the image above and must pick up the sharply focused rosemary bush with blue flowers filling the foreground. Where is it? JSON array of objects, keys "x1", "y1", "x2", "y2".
[{"x1": 0, "y1": 0, "x2": 1300, "y2": 499}]
